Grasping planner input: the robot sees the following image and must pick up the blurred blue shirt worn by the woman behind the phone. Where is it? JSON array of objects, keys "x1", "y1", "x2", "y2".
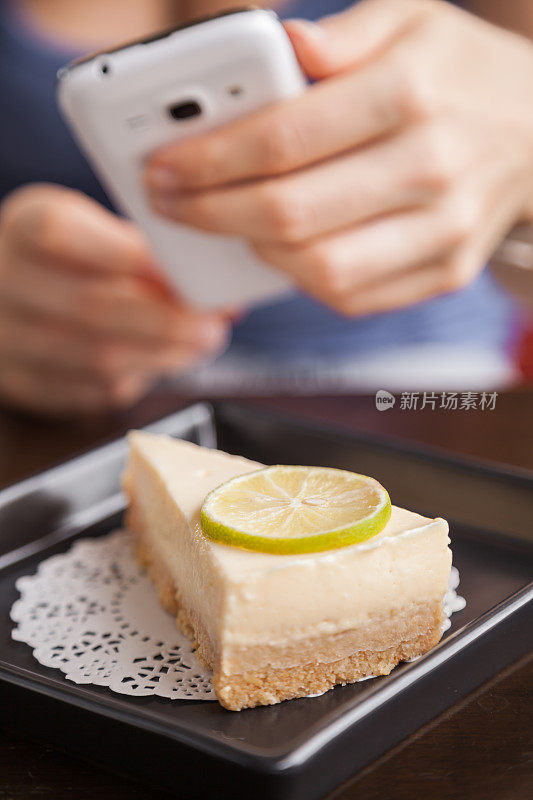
[{"x1": 0, "y1": 0, "x2": 515, "y2": 359}]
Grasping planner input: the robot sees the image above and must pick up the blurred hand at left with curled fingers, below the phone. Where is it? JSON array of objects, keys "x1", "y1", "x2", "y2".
[{"x1": 0, "y1": 184, "x2": 230, "y2": 415}]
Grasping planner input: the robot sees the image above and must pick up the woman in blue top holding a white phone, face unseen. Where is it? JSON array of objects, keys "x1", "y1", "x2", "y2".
[{"x1": 0, "y1": 0, "x2": 533, "y2": 413}]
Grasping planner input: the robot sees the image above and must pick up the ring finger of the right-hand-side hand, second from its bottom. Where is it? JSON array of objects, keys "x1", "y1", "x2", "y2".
[{"x1": 254, "y1": 203, "x2": 467, "y2": 304}]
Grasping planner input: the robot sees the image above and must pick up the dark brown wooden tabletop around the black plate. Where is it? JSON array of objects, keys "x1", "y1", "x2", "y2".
[{"x1": 0, "y1": 390, "x2": 533, "y2": 800}]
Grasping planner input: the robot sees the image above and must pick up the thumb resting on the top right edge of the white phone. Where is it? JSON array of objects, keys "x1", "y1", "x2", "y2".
[{"x1": 284, "y1": 0, "x2": 426, "y2": 80}]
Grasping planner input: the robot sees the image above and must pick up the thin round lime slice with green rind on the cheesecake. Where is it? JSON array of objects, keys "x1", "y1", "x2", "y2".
[{"x1": 200, "y1": 466, "x2": 391, "y2": 554}]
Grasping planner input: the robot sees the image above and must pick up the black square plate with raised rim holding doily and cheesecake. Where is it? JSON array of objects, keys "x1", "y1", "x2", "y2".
[{"x1": 0, "y1": 404, "x2": 533, "y2": 800}]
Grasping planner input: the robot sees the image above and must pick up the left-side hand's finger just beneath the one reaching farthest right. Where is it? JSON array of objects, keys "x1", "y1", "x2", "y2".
[{"x1": 0, "y1": 309, "x2": 222, "y2": 381}]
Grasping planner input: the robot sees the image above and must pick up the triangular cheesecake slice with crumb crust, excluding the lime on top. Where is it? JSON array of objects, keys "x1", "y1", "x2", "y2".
[{"x1": 123, "y1": 431, "x2": 451, "y2": 710}]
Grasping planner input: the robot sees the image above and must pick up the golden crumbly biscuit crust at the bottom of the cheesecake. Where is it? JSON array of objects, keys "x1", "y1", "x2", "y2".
[{"x1": 126, "y1": 503, "x2": 444, "y2": 711}]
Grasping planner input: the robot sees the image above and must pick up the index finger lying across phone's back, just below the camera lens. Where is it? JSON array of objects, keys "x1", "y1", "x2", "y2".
[{"x1": 145, "y1": 52, "x2": 420, "y2": 195}]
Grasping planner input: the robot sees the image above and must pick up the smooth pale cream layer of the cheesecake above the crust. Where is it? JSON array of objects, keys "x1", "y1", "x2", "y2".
[{"x1": 126, "y1": 432, "x2": 451, "y2": 664}]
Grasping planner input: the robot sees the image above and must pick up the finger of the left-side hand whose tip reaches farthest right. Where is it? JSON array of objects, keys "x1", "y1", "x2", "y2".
[{"x1": 1, "y1": 260, "x2": 228, "y2": 349}]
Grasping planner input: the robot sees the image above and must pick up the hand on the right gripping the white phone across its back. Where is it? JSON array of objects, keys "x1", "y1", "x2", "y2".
[{"x1": 146, "y1": 0, "x2": 533, "y2": 315}]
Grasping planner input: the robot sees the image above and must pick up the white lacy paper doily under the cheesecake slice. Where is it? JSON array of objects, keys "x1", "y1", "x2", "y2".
[{"x1": 11, "y1": 531, "x2": 465, "y2": 700}]
